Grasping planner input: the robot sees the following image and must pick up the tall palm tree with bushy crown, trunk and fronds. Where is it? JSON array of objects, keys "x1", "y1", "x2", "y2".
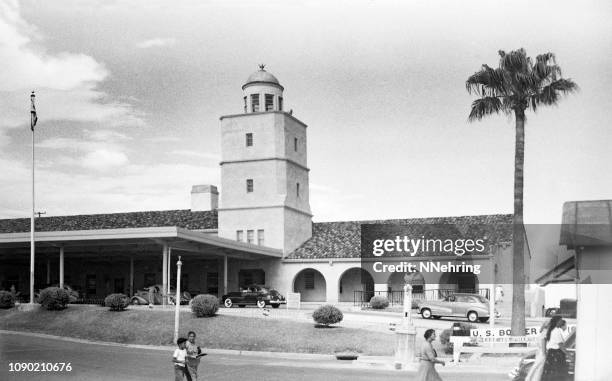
[{"x1": 465, "y1": 49, "x2": 578, "y2": 336}]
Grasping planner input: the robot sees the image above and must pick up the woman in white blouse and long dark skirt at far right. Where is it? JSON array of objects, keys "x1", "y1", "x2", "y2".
[{"x1": 542, "y1": 316, "x2": 569, "y2": 381}]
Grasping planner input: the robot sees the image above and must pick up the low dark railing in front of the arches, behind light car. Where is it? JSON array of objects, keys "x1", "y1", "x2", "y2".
[{"x1": 353, "y1": 288, "x2": 489, "y2": 308}]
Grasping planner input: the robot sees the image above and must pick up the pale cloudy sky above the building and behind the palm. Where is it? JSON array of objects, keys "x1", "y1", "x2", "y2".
[{"x1": 0, "y1": 0, "x2": 612, "y2": 223}]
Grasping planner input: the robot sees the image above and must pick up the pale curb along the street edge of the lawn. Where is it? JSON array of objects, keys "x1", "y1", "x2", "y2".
[{"x1": 0, "y1": 329, "x2": 336, "y2": 360}]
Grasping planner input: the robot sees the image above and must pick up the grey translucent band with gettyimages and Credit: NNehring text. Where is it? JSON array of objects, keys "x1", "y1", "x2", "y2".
[{"x1": 361, "y1": 223, "x2": 612, "y2": 284}]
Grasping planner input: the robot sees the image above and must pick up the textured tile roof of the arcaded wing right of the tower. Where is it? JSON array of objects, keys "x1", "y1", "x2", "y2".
[{"x1": 286, "y1": 214, "x2": 512, "y2": 259}]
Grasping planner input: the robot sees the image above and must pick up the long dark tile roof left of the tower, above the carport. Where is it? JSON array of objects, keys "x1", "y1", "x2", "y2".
[{"x1": 0, "y1": 209, "x2": 217, "y2": 234}]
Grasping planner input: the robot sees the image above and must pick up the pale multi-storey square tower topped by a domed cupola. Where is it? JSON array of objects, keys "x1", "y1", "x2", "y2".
[{"x1": 218, "y1": 65, "x2": 312, "y2": 254}]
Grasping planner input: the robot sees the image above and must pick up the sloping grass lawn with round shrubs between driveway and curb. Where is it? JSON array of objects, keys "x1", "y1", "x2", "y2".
[{"x1": 0, "y1": 306, "x2": 395, "y2": 355}]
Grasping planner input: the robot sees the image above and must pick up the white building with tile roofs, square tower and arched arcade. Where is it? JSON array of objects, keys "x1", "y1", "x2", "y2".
[{"x1": 0, "y1": 66, "x2": 529, "y2": 308}]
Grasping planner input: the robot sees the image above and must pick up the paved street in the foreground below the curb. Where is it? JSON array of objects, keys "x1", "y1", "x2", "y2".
[{"x1": 0, "y1": 334, "x2": 507, "y2": 381}]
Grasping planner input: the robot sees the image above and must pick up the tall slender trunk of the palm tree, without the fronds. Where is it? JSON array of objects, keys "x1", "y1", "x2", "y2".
[{"x1": 512, "y1": 109, "x2": 525, "y2": 336}]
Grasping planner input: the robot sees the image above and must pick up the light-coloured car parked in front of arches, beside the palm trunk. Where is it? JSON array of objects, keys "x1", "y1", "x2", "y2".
[{"x1": 418, "y1": 294, "x2": 500, "y2": 323}]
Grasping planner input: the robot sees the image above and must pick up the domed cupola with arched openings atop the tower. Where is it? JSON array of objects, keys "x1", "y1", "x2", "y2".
[{"x1": 242, "y1": 64, "x2": 284, "y2": 113}]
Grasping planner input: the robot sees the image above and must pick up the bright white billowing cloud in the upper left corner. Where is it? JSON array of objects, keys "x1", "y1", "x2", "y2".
[{"x1": 0, "y1": 0, "x2": 144, "y2": 132}]
